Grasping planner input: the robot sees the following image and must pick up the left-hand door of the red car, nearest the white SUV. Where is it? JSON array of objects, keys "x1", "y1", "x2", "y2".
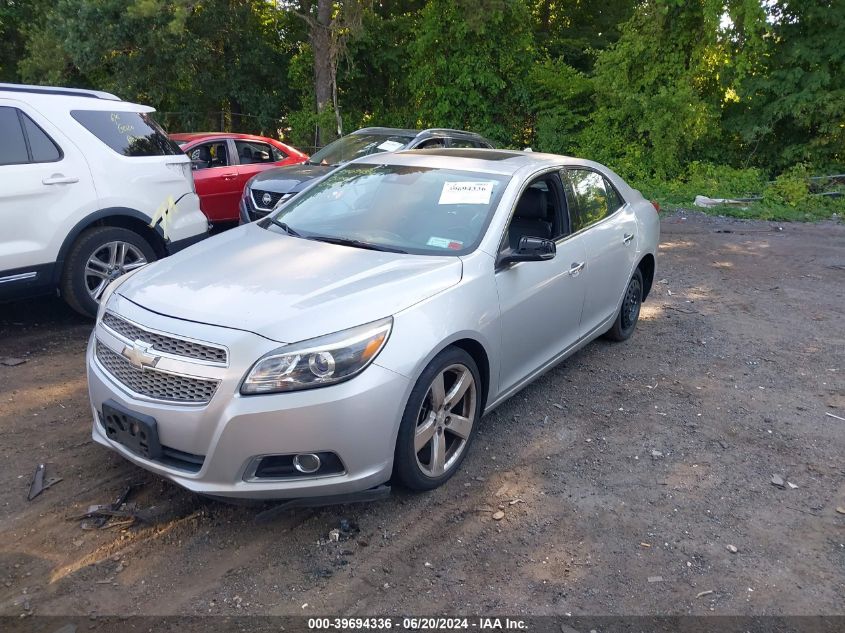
[{"x1": 187, "y1": 139, "x2": 237, "y2": 222}]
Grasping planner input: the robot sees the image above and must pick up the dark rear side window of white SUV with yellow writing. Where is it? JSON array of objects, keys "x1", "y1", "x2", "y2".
[{"x1": 70, "y1": 110, "x2": 182, "y2": 156}]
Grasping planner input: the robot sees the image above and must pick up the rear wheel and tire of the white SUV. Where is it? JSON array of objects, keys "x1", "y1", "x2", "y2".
[{"x1": 59, "y1": 226, "x2": 157, "y2": 319}]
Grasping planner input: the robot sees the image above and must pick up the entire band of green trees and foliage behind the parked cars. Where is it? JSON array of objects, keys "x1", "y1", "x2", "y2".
[{"x1": 0, "y1": 0, "x2": 845, "y2": 222}]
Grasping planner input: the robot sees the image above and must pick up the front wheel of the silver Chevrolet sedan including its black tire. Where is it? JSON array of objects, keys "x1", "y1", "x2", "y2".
[{"x1": 393, "y1": 347, "x2": 482, "y2": 490}]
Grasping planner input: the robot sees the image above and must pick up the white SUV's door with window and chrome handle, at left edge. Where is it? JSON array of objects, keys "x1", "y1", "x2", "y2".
[{"x1": 0, "y1": 99, "x2": 97, "y2": 286}]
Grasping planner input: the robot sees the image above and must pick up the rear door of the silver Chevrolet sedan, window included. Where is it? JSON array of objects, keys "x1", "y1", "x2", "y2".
[{"x1": 564, "y1": 167, "x2": 637, "y2": 336}]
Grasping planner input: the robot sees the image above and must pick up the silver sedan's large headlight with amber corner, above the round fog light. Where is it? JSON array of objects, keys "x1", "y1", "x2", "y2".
[{"x1": 241, "y1": 317, "x2": 393, "y2": 395}]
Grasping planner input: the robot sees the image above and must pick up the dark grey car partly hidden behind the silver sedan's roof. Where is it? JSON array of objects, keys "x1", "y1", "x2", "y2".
[{"x1": 240, "y1": 127, "x2": 493, "y2": 223}]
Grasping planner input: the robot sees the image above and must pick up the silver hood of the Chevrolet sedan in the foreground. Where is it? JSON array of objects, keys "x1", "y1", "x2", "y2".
[{"x1": 117, "y1": 224, "x2": 463, "y2": 343}]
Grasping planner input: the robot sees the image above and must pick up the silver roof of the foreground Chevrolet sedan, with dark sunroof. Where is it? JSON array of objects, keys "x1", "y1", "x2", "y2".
[{"x1": 355, "y1": 148, "x2": 584, "y2": 176}]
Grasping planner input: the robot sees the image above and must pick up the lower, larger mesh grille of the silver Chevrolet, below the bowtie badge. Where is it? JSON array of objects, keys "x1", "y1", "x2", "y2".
[{"x1": 96, "y1": 340, "x2": 220, "y2": 404}]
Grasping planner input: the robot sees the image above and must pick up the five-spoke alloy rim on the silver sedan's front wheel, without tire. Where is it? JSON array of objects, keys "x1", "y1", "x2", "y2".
[{"x1": 414, "y1": 364, "x2": 478, "y2": 477}]
